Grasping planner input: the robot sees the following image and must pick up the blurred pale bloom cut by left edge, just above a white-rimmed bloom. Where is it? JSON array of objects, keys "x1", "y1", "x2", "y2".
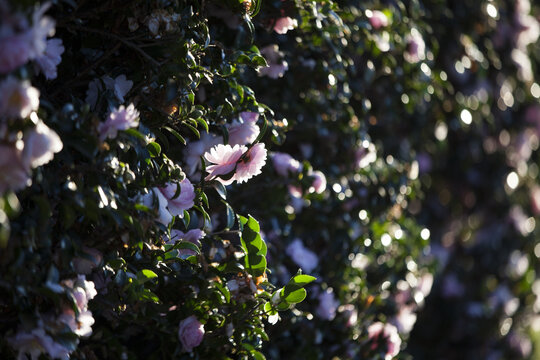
[{"x1": 0, "y1": 76, "x2": 39, "y2": 119}]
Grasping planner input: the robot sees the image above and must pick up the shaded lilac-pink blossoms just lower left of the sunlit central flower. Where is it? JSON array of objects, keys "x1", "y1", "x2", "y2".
[{"x1": 142, "y1": 178, "x2": 195, "y2": 226}]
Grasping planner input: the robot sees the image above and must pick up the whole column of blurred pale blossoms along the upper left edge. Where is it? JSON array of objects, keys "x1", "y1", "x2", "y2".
[{"x1": 0, "y1": 2, "x2": 64, "y2": 194}]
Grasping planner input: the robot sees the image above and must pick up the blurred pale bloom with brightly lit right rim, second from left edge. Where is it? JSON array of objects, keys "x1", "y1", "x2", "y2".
[{"x1": 22, "y1": 119, "x2": 64, "y2": 168}]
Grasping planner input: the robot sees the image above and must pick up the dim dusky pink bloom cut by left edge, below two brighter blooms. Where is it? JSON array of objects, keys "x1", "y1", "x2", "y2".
[{"x1": 0, "y1": 144, "x2": 30, "y2": 194}]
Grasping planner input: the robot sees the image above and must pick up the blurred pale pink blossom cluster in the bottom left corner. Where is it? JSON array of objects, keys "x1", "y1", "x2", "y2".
[{"x1": 9, "y1": 275, "x2": 97, "y2": 360}]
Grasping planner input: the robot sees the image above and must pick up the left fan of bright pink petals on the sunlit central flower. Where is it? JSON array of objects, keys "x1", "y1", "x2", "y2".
[{"x1": 204, "y1": 144, "x2": 247, "y2": 185}]
